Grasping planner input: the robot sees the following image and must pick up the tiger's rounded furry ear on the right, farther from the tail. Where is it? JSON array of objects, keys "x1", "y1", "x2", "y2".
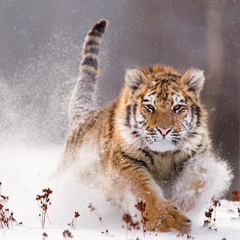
[{"x1": 181, "y1": 68, "x2": 205, "y2": 98}]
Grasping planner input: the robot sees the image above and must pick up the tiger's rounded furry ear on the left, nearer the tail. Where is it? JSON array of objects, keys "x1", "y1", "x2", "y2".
[{"x1": 125, "y1": 68, "x2": 146, "y2": 91}]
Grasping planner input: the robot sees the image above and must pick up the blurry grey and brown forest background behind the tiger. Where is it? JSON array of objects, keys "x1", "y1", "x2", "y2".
[{"x1": 0, "y1": 0, "x2": 240, "y2": 195}]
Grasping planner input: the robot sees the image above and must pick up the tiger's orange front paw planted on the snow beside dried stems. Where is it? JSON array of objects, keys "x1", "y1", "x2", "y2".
[{"x1": 145, "y1": 203, "x2": 191, "y2": 233}]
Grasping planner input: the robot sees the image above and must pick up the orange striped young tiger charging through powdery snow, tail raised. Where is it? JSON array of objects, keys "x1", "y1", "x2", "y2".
[{"x1": 59, "y1": 19, "x2": 232, "y2": 233}]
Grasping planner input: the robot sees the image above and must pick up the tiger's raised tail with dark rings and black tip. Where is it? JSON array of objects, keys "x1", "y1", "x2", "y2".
[{"x1": 68, "y1": 19, "x2": 108, "y2": 126}]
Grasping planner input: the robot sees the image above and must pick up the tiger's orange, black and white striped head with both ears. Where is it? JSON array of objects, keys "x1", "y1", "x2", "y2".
[{"x1": 120, "y1": 65, "x2": 207, "y2": 152}]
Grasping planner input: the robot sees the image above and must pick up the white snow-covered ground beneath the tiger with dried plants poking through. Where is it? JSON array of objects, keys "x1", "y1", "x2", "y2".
[{"x1": 0, "y1": 146, "x2": 240, "y2": 240}]
